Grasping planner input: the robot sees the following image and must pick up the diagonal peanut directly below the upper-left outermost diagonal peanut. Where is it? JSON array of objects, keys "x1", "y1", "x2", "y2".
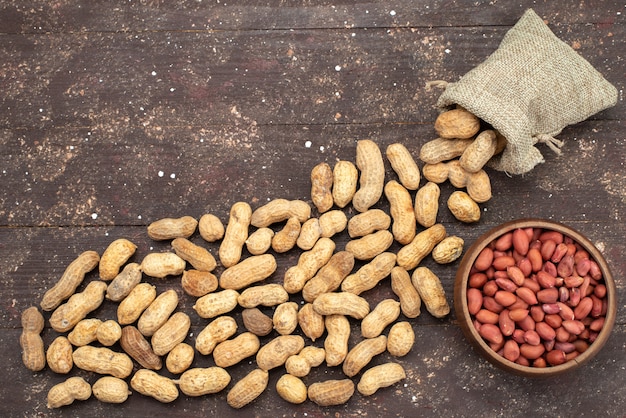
[{"x1": 50, "y1": 281, "x2": 107, "y2": 332}]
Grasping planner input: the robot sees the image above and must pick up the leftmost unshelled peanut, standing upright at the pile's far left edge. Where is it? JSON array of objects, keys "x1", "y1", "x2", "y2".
[{"x1": 20, "y1": 306, "x2": 46, "y2": 372}]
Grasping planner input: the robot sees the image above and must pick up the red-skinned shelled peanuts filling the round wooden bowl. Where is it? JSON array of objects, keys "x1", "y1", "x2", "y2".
[{"x1": 467, "y1": 228, "x2": 607, "y2": 367}]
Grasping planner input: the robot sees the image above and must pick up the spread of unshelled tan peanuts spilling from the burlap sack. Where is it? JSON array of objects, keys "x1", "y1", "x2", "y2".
[{"x1": 20, "y1": 109, "x2": 516, "y2": 408}]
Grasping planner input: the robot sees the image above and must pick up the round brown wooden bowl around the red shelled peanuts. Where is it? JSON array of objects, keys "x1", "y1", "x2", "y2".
[{"x1": 454, "y1": 219, "x2": 617, "y2": 377}]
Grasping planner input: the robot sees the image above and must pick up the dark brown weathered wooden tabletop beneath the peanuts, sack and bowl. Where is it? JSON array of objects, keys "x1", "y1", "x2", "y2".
[{"x1": 0, "y1": 0, "x2": 626, "y2": 417}]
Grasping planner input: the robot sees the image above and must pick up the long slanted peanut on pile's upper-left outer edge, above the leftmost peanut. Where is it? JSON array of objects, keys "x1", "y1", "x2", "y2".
[{"x1": 40, "y1": 251, "x2": 100, "y2": 311}]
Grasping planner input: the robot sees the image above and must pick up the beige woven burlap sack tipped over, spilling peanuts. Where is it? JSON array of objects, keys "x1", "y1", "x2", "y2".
[{"x1": 437, "y1": 9, "x2": 617, "y2": 174}]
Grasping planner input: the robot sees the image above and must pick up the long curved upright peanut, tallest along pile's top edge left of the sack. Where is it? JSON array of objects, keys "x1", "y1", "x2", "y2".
[{"x1": 352, "y1": 139, "x2": 385, "y2": 212}]
